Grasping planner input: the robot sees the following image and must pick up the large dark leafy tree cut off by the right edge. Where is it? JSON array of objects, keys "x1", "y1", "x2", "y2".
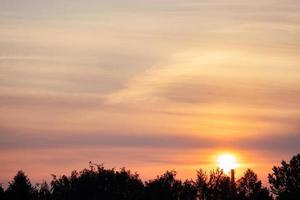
[{"x1": 269, "y1": 154, "x2": 300, "y2": 200}]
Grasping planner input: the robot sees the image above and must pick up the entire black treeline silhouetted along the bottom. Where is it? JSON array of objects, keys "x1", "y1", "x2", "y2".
[{"x1": 0, "y1": 154, "x2": 300, "y2": 200}]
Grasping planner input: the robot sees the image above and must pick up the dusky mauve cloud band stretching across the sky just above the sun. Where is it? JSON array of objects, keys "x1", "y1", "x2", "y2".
[{"x1": 0, "y1": 128, "x2": 300, "y2": 152}]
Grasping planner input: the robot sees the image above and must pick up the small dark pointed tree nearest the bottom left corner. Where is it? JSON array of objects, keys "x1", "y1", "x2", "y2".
[{"x1": 5, "y1": 171, "x2": 37, "y2": 200}]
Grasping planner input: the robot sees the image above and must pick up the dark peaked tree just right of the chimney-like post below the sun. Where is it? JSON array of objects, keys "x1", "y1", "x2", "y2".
[{"x1": 237, "y1": 169, "x2": 272, "y2": 200}]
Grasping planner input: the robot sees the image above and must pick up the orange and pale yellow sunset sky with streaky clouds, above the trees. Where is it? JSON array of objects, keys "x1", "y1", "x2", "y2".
[{"x1": 0, "y1": 0, "x2": 300, "y2": 184}]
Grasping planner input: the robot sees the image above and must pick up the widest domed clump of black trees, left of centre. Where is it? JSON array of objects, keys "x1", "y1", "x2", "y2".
[{"x1": 51, "y1": 165, "x2": 144, "y2": 200}]
